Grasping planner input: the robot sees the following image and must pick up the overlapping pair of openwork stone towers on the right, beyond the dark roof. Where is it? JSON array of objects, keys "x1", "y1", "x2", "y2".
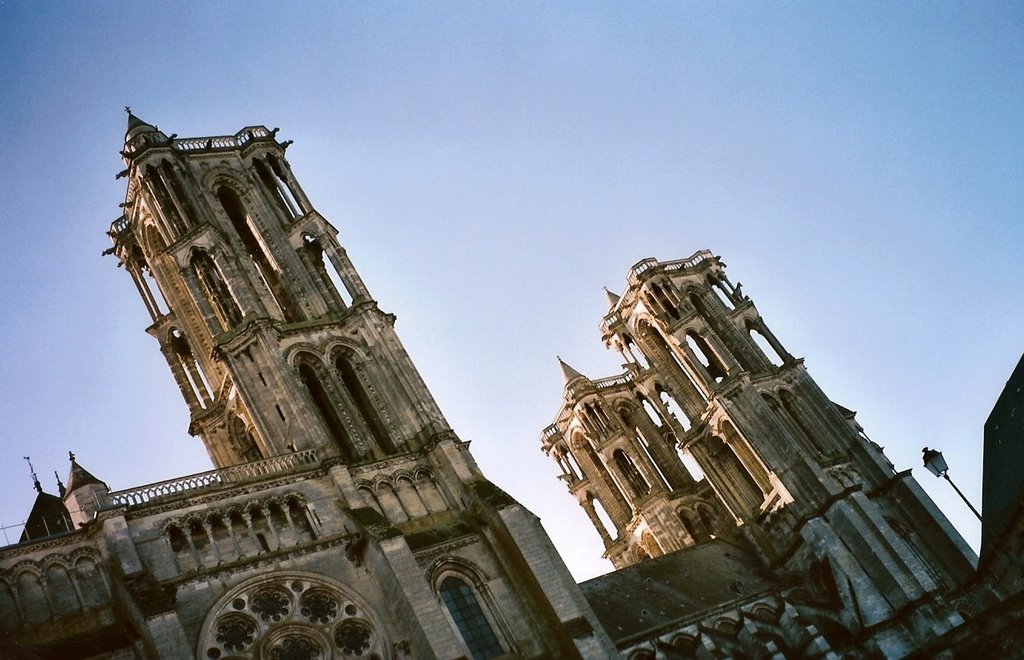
[{"x1": 541, "y1": 251, "x2": 975, "y2": 655}]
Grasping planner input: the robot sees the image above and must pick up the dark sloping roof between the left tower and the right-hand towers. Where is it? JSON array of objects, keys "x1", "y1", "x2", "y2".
[{"x1": 580, "y1": 539, "x2": 782, "y2": 645}]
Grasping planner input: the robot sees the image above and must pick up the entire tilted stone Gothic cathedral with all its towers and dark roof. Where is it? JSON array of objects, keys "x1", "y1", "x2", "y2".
[{"x1": 0, "y1": 113, "x2": 1006, "y2": 660}]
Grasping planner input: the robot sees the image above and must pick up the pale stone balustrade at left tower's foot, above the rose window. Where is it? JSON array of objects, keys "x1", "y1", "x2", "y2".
[{"x1": 110, "y1": 449, "x2": 318, "y2": 507}]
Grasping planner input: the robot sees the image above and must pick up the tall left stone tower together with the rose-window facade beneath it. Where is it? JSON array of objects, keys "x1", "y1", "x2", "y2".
[{"x1": 94, "y1": 113, "x2": 614, "y2": 658}]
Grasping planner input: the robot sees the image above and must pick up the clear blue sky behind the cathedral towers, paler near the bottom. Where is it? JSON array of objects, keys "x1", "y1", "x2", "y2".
[{"x1": 0, "y1": 0, "x2": 1024, "y2": 579}]
